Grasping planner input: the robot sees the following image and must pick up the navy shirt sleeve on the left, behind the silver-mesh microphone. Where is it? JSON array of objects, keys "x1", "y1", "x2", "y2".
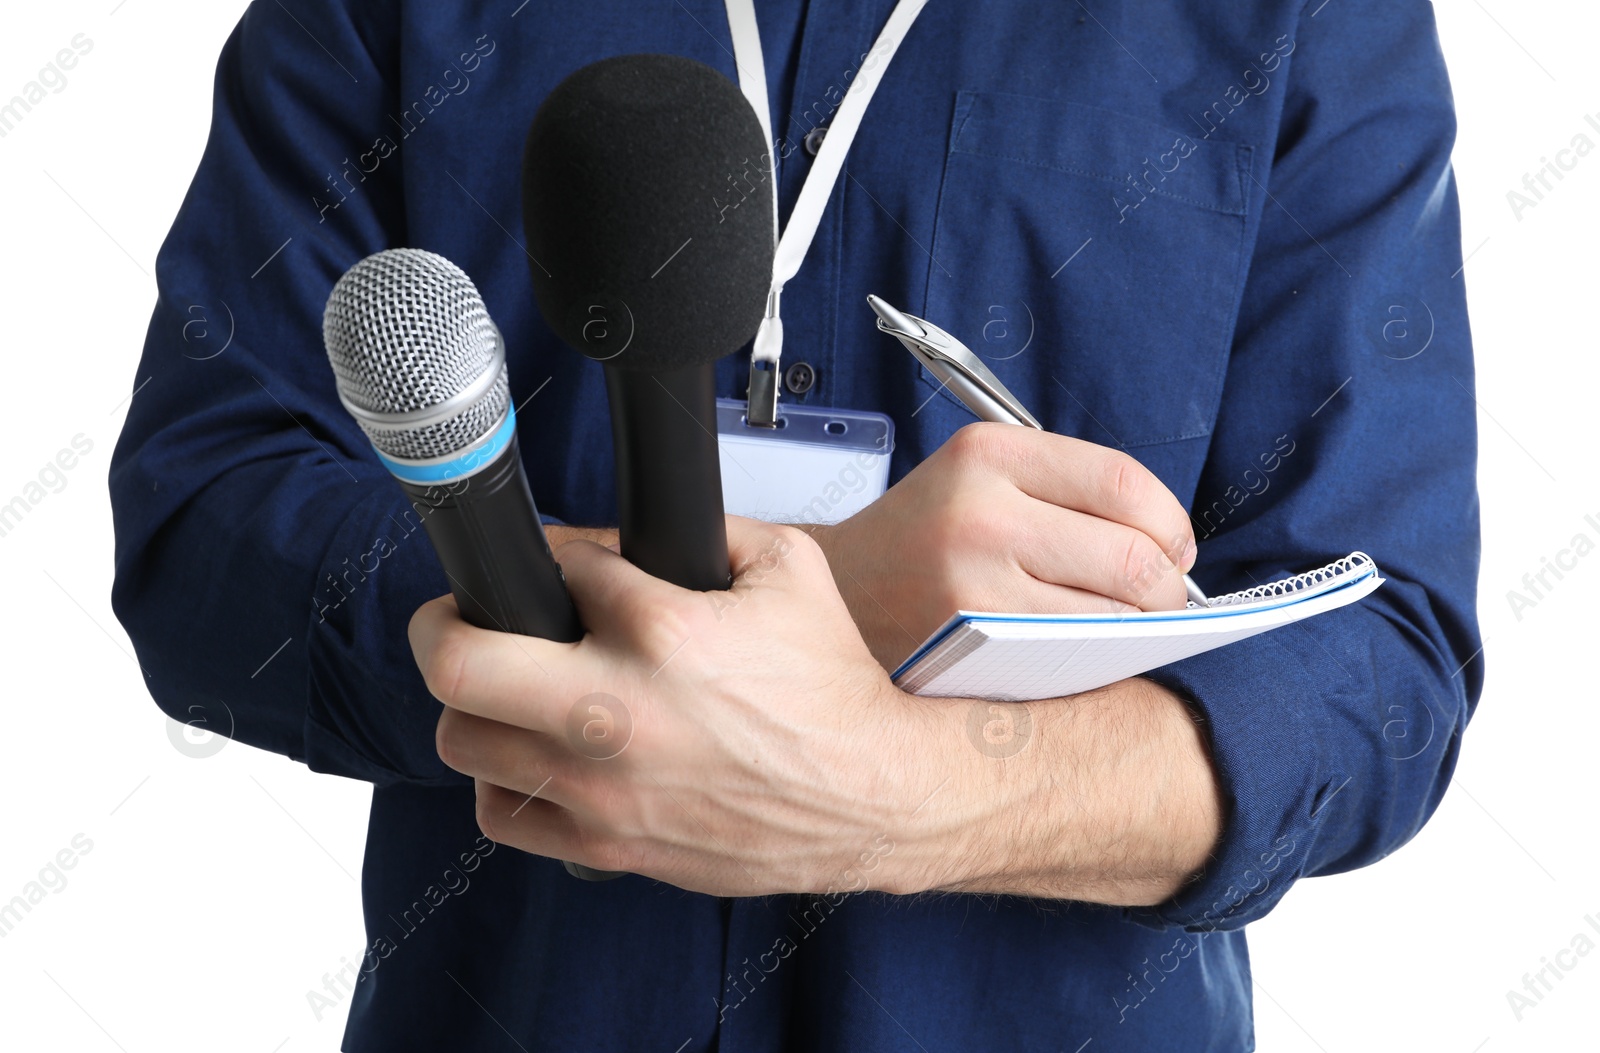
[{"x1": 110, "y1": 3, "x2": 458, "y2": 783}]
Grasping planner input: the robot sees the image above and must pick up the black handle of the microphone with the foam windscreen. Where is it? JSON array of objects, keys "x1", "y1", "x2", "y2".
[{"x1": 605, "y1": 363, "x2": 733, "y2": 592}]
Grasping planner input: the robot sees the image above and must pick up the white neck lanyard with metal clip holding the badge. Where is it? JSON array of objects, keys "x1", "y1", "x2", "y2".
[{"x1": 726, "y1": 0, "x2": 928, "y2": 424}]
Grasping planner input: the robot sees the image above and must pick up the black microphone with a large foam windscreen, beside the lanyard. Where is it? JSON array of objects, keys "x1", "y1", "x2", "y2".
[{"x1": 522, "y1": 54, "x2": 774, "y2": 591}]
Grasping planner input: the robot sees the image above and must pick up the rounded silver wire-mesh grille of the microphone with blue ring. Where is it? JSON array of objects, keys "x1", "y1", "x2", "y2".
[{"x1": 322, "y1": 248, "x2": 510, "y2": 461}]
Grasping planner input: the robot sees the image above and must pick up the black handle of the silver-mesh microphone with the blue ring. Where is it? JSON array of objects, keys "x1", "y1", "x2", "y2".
[{"x1": 400, "y1": 434, "x2": 622, "y2": 882}]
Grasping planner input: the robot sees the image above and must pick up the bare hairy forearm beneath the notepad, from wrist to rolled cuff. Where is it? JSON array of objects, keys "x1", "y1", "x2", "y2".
[{"x1": 896, "y1": 679, "x2": 1222, "y2": 906}]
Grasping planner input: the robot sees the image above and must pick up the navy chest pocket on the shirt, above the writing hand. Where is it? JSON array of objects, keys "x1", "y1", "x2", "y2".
[{"x1": 925, "y1": 91, "x2": 1251, "y2": 446}]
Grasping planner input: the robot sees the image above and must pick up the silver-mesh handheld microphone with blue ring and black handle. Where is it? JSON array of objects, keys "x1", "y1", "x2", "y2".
[{"x1": 322, "y1": 248, "x2": 621, "y2": 882}]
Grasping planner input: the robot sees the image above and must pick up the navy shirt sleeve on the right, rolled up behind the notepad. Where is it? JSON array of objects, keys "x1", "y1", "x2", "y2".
[{"x1": 1130, "y1": 2, "x2": 1483, "y2": 931}]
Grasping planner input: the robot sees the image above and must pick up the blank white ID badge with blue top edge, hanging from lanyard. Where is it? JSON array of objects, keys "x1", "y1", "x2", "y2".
[{"x1": 717, "y1": 398, "x2": 894, "y2": 525}]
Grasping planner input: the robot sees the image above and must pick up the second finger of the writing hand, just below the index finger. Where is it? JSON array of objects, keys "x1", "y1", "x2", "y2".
[{"x1": 1016, "y1": 501, "x2": 1187, "y2": 611}]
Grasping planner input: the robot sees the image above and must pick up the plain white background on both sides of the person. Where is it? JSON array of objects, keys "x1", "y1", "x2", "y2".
[{"x1": 0, "y1": 0, "x2": 1600, "y2": 1053}]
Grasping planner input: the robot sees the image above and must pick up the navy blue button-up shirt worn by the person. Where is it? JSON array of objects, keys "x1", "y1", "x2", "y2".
[{"x1": 110, "y1": 0, "x2": 1483, "y2": 1053}]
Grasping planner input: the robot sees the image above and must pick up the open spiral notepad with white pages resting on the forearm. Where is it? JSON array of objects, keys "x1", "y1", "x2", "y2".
[{"x1": 894, "y1": 552, "x2": 1384, "y2": 701}]
